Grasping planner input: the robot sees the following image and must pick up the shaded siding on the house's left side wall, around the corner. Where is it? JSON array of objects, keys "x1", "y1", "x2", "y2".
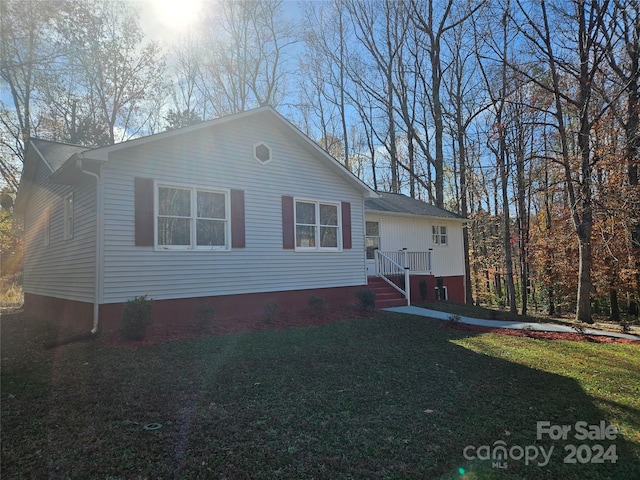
[{"x1": 24, "y1": 163, "x2": 96, "y2": 302}]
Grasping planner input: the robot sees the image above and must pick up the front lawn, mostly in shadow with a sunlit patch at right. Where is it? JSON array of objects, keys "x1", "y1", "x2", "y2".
[{"x1": 1, "y1": 314, "x2": 640, "y2": 479}]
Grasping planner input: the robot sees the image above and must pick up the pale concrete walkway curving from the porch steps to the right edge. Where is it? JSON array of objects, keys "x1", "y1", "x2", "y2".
[{"x1": 384, "y1": 306, "x2": 640, "y2": 340}]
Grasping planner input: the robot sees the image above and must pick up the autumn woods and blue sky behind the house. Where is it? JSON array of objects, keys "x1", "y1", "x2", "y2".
[{"x1": 0, "y1": 0, "x2": 640, "y2": 322}]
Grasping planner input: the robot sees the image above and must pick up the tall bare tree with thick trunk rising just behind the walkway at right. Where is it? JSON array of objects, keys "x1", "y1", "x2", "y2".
[{"x1": 516, "y1": 0, "x2": 610, "y2": 323}]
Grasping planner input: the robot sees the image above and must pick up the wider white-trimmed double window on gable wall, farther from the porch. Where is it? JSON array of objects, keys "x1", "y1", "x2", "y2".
[{"x1": 155, "y1": 184, "x2": 230, "y2": 250}]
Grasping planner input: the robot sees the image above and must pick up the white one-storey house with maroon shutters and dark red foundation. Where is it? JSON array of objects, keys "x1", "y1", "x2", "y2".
[{"x1": 16, "y1": 107, "x2": 461, "y2": 332}]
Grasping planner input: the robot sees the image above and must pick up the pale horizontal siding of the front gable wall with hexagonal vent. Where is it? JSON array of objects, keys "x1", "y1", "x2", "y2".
[{"x1": 104, "y1": 117, "x2": 366, "y2": 303}]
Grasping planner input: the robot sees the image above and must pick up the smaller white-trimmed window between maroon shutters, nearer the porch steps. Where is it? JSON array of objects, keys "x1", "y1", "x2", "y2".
[{"x1": 295, "y1": 200, "x2": 342, "y2": 250}]
